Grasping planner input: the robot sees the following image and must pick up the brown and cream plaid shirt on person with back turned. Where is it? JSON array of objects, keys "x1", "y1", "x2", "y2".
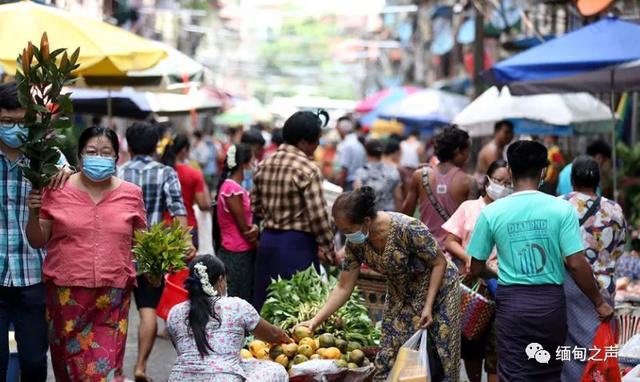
[{"x1": 251, "y1": 144, "x2": 333, "y2": 248}]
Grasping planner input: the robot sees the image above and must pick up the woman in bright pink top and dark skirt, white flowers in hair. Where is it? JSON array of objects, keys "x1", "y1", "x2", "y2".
[{"x1": 214, "y1": 143, "x2": 258, "y2": 301}]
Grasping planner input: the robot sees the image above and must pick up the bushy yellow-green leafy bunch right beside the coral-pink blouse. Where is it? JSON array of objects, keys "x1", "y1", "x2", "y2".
[{"x1": 133, "y1": 222, "x2": 191, "y2": 284}]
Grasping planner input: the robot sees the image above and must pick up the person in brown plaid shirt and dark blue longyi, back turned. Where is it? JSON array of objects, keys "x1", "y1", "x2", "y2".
[{"x1": 251, "y1": 111, "x2": 335, "y2": 310}]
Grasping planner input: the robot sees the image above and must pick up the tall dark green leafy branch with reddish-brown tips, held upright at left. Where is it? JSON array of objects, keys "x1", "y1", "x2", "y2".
[{"x1": 16, "y1": 33, "x2": 80, "y2": 189}]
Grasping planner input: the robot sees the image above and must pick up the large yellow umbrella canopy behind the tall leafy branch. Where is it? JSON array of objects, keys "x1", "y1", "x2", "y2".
[{"x1": 0, "y1": 1, "x2": 167, "y2": 76}]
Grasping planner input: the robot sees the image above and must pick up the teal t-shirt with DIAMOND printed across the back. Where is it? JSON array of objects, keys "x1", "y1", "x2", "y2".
[{"x1": 467, "y1": 191, "x2": 584, "y2": 285}]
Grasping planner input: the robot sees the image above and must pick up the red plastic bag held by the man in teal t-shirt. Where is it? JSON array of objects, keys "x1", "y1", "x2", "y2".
[{"x1": 582, "y1": 322, "x2": 622, "y2": 382}]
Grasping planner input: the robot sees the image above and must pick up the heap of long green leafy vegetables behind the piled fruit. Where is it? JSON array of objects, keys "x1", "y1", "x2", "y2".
[{"x1": 260, "y1": 266, "x2": 380, "y2": 346}]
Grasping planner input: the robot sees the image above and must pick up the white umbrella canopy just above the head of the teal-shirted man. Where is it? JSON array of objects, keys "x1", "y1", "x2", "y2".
[{"x1": 453, "y1": 86, "x2": 611, "y2": 136}]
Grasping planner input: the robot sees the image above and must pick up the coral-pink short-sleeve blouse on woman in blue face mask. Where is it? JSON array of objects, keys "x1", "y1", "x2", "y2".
[{"x1": 40, "y1": 181, "x2": 147, "y2": 288}]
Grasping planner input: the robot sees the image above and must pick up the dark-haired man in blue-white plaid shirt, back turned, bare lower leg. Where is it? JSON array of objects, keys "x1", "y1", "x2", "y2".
[{"x1": 118, "y1": 122, "x2": 195, "y2": 380}]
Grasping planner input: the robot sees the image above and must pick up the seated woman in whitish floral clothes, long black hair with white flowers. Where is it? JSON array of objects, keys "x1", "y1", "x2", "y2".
[{"x1": 167, "y1": 255, "x2": 291, "y2": 382}]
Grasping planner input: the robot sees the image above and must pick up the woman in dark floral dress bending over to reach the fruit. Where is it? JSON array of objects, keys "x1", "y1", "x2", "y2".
[{"x1": 301, "y1": 187, "x2": 460, "y2": 382}]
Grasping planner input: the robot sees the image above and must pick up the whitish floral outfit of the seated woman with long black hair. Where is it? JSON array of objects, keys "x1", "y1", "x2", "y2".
[{"x1": 167, "y1": 297, "x2": 289, "y2": 382}]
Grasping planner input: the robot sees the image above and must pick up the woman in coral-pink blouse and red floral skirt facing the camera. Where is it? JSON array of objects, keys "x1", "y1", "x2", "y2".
[{"x1": 27, "y1": 127, "x2": 146, "y2": 382}]
